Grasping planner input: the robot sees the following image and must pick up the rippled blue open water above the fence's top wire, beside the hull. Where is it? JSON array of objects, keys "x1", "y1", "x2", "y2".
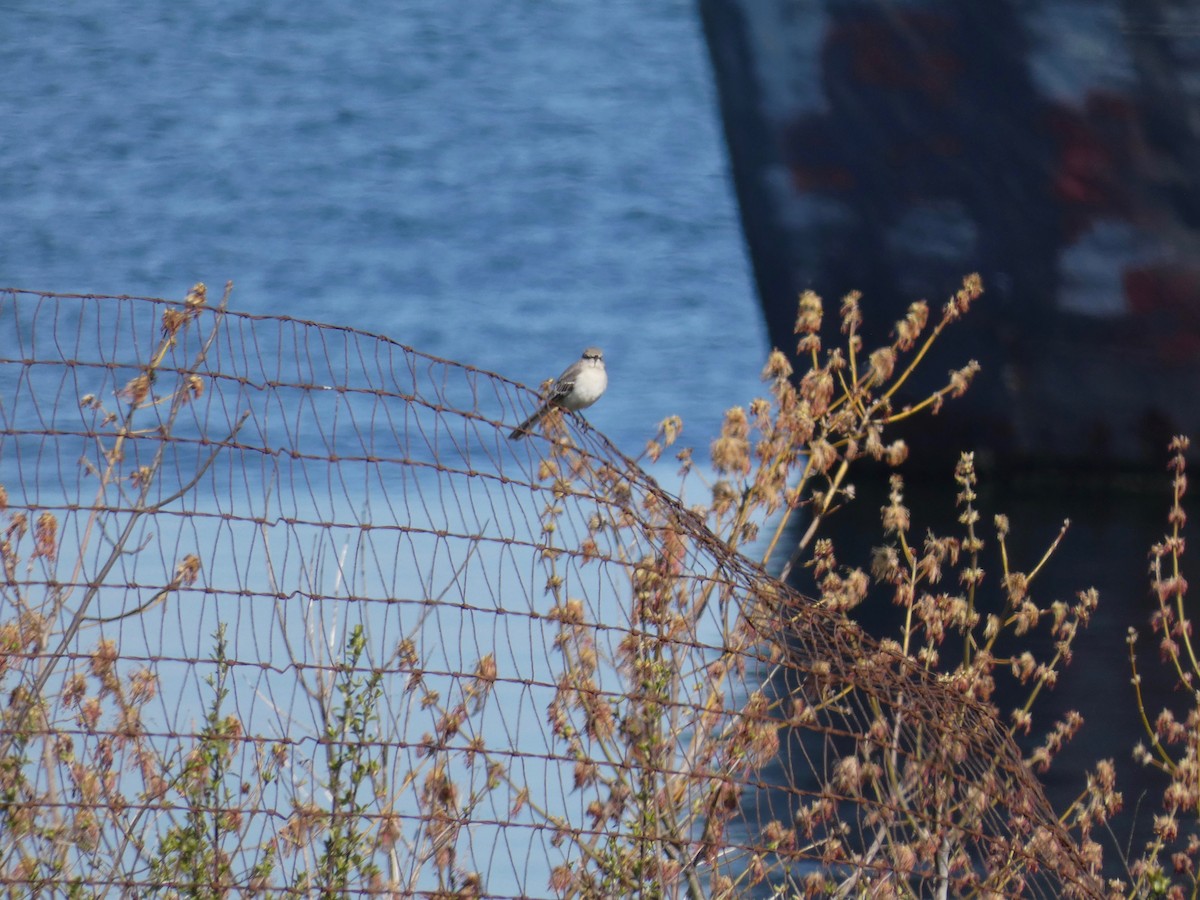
[{"x1": 0, "y1": 0, "x2": 766, "y2": 451}]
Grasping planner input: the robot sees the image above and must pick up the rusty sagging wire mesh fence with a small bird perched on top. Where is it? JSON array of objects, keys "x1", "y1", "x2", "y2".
[{"x1": 0, "y1": 286, "x2": 1098, "y2": 896}]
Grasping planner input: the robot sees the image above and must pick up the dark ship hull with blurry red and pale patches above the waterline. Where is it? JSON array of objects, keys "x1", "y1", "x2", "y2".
[{"x1": 700, "y1": 0, "x2": 1200, "y2": 469}]
